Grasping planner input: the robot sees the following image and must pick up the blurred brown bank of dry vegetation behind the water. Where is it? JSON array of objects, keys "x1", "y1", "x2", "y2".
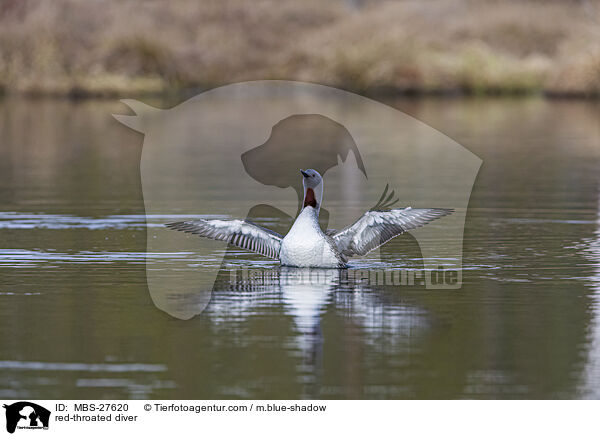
[{"x1": 0, "y1": 0, "x2": 600, "y2": 97}]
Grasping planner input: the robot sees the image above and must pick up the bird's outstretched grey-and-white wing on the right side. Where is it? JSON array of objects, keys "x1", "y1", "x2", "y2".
[{"x1": 332, "y1": 207, "x2": 454, "y2": 257}]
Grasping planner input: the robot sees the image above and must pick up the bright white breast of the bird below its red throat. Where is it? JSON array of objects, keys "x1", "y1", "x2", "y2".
[{"x1": 279, "y1": 206, "x2": 340, "y2": 268}]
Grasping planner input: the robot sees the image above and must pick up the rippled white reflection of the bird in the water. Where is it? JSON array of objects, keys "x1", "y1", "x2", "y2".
[{"x1": 205, "y1": 266, "x2": 430, "y2": 396}]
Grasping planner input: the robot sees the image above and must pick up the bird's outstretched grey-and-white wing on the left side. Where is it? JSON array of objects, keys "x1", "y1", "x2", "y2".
[{"x1": 165, "y1": 219, "x2": 283, "y2": 259}]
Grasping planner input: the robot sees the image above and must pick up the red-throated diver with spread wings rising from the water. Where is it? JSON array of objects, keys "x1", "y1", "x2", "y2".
[{"x1": 165, "y1": 169, "x2": 454, "y2": 268}]
